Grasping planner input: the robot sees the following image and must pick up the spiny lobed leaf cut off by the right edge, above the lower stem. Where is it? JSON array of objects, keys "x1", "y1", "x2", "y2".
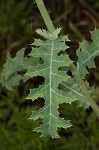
[{"x1": 77, "y1": 29, "x2": 99, "y2": 76}]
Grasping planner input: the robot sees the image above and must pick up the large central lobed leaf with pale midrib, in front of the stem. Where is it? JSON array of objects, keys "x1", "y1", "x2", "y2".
[{"x1": 26, "y1": 28, "x2": 75, "y2": 138}]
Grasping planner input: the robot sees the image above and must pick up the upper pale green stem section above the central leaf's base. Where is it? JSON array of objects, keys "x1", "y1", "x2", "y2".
[{"x1": 35, "y1": 0, "x2": 55, "y2": 33}]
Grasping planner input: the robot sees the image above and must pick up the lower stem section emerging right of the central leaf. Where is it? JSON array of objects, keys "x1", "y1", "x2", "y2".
[{"x1": 70, "y1": 64, "x2": 99, "y2": 117}]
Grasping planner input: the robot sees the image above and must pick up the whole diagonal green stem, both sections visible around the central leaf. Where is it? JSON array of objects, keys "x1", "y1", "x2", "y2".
[{"x1": 35, "y1": 0, "x2": 99, "y2": 117}]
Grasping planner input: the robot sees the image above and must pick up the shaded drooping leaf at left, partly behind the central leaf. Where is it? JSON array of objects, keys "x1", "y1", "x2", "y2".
[{"x1": 0, "y1": 48, "x2": 35, "y2": 90}]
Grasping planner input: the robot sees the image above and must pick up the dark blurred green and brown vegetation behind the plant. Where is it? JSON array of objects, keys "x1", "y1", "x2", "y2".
[{"x1": 0, "y1": 0, "x2": 99, "y2": 150}]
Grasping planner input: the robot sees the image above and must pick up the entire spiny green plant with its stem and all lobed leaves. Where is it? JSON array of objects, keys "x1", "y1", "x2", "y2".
[{"x1": 1, "y1": 0, "x2": 99, "y2": 138}]
